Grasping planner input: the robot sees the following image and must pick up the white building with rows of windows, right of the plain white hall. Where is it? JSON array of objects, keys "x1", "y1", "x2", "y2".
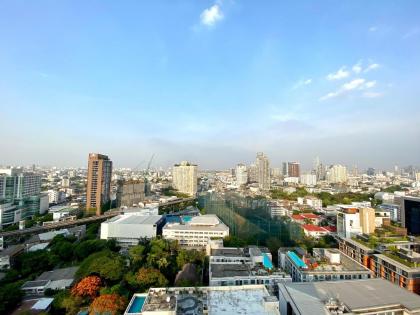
[{"x1": 162, "y1": 214, "x2": 229, "y2": 248}]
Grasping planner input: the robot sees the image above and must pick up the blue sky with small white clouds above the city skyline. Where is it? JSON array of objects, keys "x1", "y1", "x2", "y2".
[{"x1": 0, "y1": 0, "x2": 420, "y2": 168}]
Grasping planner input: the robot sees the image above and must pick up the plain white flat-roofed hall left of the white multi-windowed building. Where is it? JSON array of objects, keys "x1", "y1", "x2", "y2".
[{"x1": 101, "y1": 214, "x2": 165, "y2": 247}]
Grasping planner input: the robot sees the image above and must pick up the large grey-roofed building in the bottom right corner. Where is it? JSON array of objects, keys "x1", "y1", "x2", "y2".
[{"x1": 279, "y1": 279, "x2": 420, "y2": 315}]
